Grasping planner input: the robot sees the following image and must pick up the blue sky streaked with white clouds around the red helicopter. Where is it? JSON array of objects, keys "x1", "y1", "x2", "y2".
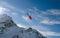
[{"x1": 0, "y1": 0, "x2": 60, "y2": 38}]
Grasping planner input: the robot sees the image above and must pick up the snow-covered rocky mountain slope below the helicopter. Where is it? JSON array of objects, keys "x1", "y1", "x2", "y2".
[{"x1": 0, "y1": 14, "x2": 45, "y2": 38}]
